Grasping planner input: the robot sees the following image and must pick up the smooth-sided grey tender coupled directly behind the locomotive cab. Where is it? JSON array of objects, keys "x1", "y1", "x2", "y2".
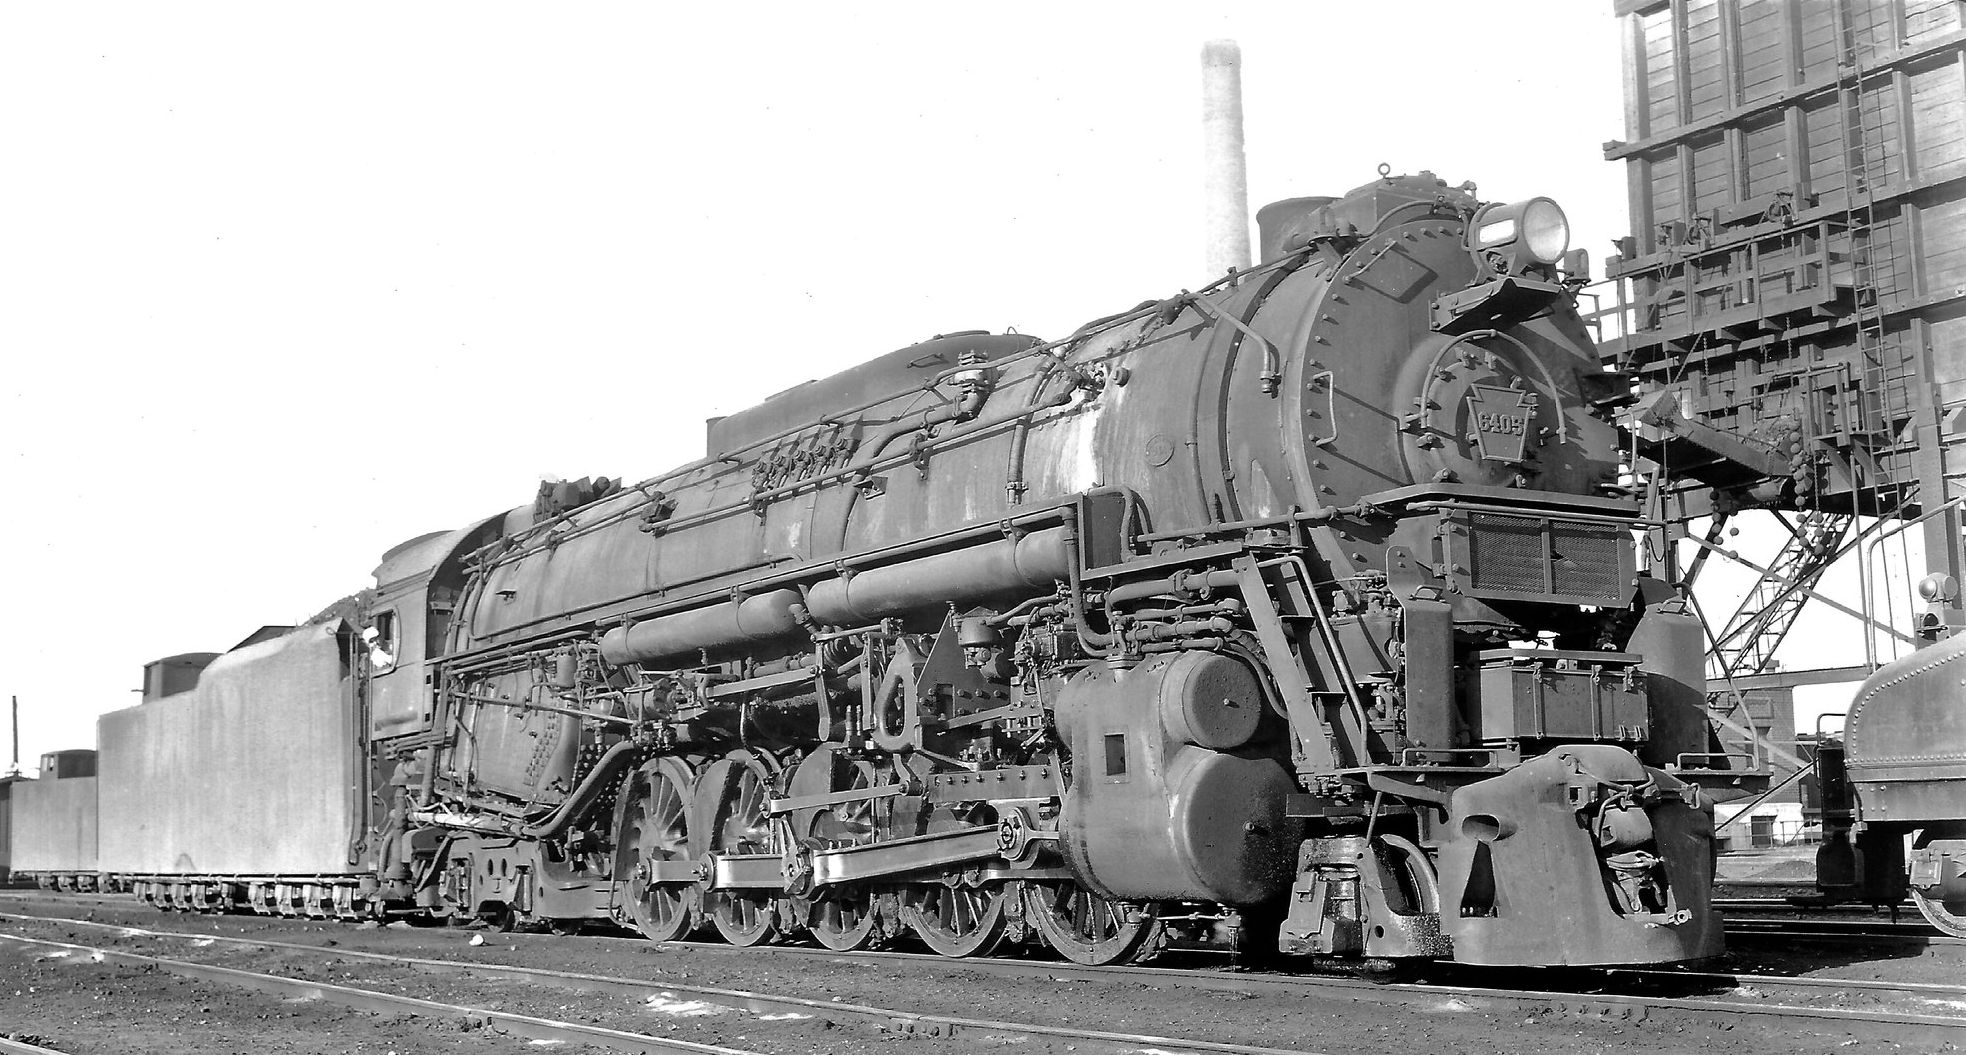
[{"x1": 96, "y1": 613, "x2": 379, "y2": 917}]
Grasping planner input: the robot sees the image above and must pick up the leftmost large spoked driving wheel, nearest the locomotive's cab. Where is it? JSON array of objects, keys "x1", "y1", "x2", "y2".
[{"x1": 615, "y1": 758, "x2": 696, "y2": 941}]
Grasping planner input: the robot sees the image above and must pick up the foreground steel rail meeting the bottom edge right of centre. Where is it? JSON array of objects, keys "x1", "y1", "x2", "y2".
[{"x1": 0, "y1": 914, "x2": 1336, "y2": 1055}]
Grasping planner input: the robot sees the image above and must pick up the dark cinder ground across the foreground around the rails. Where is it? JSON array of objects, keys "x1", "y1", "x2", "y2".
[{"x1": 0, "y1": 898, "x2": 1958, "y2": 1055}]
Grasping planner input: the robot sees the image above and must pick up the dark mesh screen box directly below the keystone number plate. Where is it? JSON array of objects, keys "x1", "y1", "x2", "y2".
[{"x1": 1467, "y1": 513, "x2": 1630, "y2": 603}]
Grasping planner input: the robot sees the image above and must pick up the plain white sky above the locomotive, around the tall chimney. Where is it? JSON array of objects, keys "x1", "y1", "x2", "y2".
[{"x1": 0, "y1": 0, "x2": 1903, "y2": 766}]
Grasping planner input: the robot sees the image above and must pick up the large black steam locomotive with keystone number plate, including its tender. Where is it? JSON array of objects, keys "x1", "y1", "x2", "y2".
[{"x1": 53, "y1": 173, "x2": 1738, "y2": 965}]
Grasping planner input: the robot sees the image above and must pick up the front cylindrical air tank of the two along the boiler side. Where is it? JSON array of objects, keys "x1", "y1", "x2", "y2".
[{"x1": 806, "y1": 528, "x2": 1068, "y2": 625}]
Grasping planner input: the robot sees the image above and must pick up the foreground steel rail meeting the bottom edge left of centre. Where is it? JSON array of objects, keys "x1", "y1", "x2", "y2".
[{"x1": 0, "y1": 933, "x2": 757, "y2": 1055}]
